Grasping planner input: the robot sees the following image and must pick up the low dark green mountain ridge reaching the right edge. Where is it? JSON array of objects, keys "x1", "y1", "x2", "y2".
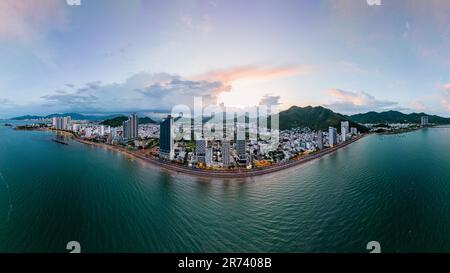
[{"x1": 350, "y1": 111, "x2": 450, "y2": 124}]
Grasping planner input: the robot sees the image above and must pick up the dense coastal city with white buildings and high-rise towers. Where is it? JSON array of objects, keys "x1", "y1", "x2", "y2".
[{"x1": 11, "y1": 108, "x2": 430, "y2": 171}]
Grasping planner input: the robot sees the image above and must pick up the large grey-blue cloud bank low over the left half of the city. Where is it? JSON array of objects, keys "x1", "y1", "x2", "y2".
[{"x1": 41, "y1": 72, "x2": 230, "y2": 112}]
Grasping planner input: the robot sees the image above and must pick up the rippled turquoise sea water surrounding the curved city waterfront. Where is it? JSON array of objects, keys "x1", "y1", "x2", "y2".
[{"x1": 0, "y1": 120, "x2": 450, "y2": 252}]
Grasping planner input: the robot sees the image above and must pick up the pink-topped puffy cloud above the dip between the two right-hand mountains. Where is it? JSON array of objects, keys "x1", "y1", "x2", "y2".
[{"x1": 325, "y1": 89, "x2": 398, "y2": 113}]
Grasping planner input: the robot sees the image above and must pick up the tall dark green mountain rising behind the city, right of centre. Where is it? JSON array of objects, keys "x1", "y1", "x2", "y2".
[{"x1": 279, "y1": 106, "x2": 368, "y2": 132}]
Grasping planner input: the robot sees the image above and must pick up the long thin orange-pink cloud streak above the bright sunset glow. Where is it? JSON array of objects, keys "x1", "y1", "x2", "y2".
[{"x1": 193, "y1": 65, "x2": 312, "y2": 83}]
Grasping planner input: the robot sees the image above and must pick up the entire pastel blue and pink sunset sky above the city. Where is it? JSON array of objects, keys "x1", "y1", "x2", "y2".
[{"x1": 0, "y1": 0, "x2": 450, "y2": 117}]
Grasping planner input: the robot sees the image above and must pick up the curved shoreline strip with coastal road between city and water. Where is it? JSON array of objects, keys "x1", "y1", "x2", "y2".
[{"x1": 72, "y1": 134, "x2": 368, "y2": 178}]
